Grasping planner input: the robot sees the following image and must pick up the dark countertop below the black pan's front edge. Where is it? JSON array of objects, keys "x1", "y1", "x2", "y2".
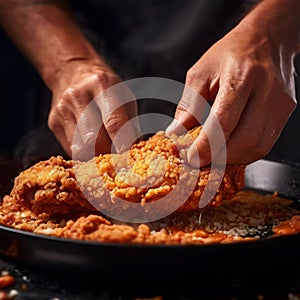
[{"x1": 0, "y1": 255, "x2": 300, "y2": 300}]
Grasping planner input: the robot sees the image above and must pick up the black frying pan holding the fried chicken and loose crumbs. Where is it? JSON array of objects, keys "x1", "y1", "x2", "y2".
[{"x1": 0, "y1": 160, "x2": 300, "y2": 290}]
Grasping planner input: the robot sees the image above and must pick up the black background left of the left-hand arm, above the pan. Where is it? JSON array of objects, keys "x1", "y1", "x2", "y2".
[{"x1": 0, "y1": 30, "x2": 65, "y2": 167}]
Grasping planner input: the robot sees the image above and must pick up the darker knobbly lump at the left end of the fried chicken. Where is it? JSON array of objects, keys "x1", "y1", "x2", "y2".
[{"x1": 11, "y1": 156, "x2": 93, "y2": 214}]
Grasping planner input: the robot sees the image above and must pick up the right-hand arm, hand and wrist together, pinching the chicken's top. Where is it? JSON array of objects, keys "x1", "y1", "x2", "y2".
[{"x1": 166, "y1": 0, "x2": 300, "y2": 168}]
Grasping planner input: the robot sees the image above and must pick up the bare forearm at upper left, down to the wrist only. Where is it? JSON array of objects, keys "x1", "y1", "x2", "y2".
[{"x1": 0, "y1": 0, "x2": 107, "y2": 89}]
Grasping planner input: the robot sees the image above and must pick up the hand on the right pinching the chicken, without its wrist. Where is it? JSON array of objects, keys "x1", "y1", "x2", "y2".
[{"x1": 167, "y1": 1, "x2": 296, "y2": 167}]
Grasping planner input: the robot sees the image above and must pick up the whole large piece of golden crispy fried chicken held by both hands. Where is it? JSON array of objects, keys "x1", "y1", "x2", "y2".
[{"x1": 10, "y1": 127, "x2": 245, "y2": 219}]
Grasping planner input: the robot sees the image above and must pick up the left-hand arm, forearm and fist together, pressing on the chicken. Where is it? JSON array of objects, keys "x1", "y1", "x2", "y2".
[{"x1": 0, "y1": 0, "x2": 136, "y2": 159}]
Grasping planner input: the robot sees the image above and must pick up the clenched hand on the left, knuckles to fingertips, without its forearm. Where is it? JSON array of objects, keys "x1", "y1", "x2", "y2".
[{"x1": 48, "y1": 61, "x2": 137, "y2": 160}]
